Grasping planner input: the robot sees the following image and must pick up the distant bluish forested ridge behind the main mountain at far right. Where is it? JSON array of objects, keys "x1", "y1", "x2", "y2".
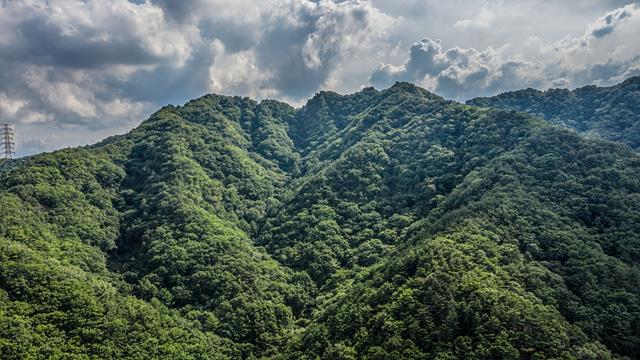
[{"x1": 467, "y1": 76, "x2": 640, "y2": 150}]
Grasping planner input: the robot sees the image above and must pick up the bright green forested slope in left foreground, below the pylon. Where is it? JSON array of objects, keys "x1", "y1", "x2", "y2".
[{"x1": 0, "y1": 149, "x2": 239, "y2": 359}]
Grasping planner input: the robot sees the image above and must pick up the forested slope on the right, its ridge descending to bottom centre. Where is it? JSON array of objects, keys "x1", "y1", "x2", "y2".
[{"x1": 293, "y1": 119, "x2": 640, "y2": 358}]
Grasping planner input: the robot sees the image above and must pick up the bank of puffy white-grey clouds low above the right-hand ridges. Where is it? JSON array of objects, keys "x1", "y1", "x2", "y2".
[{"x1": 369, "y1": 4, "x2": 640, "y2": 99}]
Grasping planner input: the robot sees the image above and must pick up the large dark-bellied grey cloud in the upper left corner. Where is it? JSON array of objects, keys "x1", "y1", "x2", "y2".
[{"x1": 0, "y1": 0, "x2": 198, "y2": 68}]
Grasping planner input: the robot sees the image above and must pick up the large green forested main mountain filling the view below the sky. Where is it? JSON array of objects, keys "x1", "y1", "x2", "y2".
[{"x1": 0, "y1": 79, "x2": 640, "y2": 359}]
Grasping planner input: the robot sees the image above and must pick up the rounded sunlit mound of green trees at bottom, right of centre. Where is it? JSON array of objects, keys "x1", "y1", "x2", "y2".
[{"x1": 284, "y1": 228, "x2": 609, "y2": 359}]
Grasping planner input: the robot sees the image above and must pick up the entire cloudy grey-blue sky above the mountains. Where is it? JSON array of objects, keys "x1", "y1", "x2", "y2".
[{"x1": 0, "y1": 0, "x2": 640, "y2": 156}]
